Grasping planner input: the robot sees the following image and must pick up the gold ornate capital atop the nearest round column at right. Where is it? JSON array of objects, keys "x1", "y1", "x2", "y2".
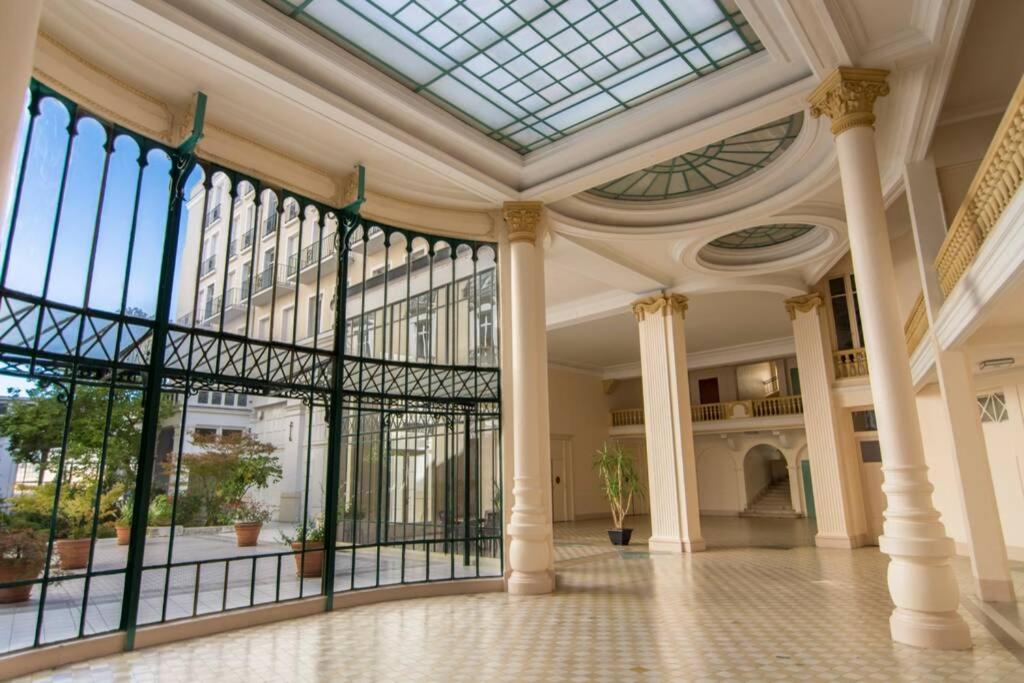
[{"x1": 807, "y1": 67, "x2": 889, "y2": 135}]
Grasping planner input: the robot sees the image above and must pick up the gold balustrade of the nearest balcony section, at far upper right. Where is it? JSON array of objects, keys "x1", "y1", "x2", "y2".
[{"x1": 935, "y1": 78, "x2": 1024, "y2": 296}]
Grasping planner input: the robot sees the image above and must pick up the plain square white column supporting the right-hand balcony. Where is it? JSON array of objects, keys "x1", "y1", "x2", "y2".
[{"x1": 903, "y1": 159, "x2": 1017, "y2": 602}]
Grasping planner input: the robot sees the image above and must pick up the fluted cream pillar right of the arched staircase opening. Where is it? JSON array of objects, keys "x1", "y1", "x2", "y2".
[{"x1": 785, "y1": 296, "x2": 864, "y2": 548}]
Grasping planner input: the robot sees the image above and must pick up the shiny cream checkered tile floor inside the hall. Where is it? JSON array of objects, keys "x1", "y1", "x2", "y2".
[{"x1": 14, "y1": 518, "x2": 1024, "y2": 682}]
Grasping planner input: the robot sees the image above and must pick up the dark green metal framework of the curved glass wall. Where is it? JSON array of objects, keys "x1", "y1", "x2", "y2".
[{"x1": 0, "y1": 81, "x2": 504, "y2": 653}]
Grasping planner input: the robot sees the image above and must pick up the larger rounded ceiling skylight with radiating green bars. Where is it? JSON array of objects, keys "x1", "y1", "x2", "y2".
[{"x1": 588, "y1": 112, "x2": 804, "y2": 202}]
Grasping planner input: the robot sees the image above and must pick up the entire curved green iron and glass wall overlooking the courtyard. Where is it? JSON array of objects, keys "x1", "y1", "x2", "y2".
[{"x1": 0, "y1": 83, "x2": 502, "y2": 652}]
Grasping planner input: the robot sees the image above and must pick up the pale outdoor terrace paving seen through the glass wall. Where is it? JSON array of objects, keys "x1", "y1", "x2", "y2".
[{"x1": 0, "y1": 524, "x2": 501, "y2": 655}]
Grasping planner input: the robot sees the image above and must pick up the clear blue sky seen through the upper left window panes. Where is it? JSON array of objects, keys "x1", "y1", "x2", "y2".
[{"x1": 0, "y1": 98, "x2": 200, "y2": 392}]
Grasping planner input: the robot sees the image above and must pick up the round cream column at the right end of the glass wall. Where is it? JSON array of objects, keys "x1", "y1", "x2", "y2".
[{"x1": 502, "y1": 202, "x2": 555, "y2": 595}]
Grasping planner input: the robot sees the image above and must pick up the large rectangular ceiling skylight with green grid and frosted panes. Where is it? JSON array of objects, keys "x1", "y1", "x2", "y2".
[{"x1": 267, "y1": 0, "x2": 762, "y2": 154}]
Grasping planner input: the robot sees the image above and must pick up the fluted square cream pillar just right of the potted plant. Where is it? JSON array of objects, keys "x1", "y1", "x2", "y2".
[{"x1": 633, "y1": 294, "x2": 705, "y2": 553}]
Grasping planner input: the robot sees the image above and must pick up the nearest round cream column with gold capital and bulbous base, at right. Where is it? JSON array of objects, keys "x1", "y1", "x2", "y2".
[{"x1": 809, "y1": 68, "x2": 971, "y2": 649}]
